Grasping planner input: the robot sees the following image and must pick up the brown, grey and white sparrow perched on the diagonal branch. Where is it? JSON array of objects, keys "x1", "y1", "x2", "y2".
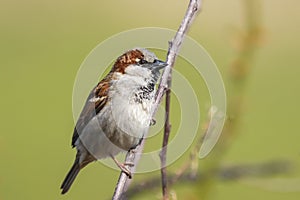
[{"x1": 61, "y1": 48, "x2": 167, "y2": 194}]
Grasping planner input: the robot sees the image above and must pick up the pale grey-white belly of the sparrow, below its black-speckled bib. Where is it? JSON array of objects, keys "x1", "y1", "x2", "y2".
[{"x1": 76, "y1": 99, "x2": 152, "y2": 159}]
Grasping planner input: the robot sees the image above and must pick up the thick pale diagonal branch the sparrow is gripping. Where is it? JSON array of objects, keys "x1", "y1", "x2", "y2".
[{"x1": 112, "y1": 0, "x2": 202, "y2": 200}]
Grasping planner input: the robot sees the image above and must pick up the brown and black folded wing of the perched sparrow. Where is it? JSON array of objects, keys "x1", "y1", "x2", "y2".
[{"x1": 72, "y1": 74, "x2": 111, "y2": 147}]
